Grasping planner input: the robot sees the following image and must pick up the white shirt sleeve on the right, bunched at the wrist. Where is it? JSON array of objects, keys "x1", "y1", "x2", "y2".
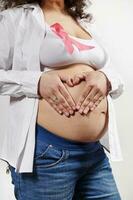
[{"x1": 88, "y1": 23, "x2": 125, "y2": 99}]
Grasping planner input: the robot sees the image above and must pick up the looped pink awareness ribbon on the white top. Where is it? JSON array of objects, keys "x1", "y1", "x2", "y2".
[{"x1": 50, "y1": 23, "x2": 95, "y2": 54}]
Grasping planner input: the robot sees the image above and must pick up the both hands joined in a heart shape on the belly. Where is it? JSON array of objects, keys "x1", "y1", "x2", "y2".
[{"x1": 39, "y1": 70, "x2": 111, "y2": 117}]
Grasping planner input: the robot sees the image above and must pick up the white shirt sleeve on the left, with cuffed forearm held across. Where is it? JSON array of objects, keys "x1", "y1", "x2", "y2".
[{"x1": 0, "y1": 11, "x2": 43, "y2": 98}]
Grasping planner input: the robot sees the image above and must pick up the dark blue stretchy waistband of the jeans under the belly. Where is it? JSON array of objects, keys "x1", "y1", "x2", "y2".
[{"x1": 36, "y1": 123, "x2": 102, "y2": 151}]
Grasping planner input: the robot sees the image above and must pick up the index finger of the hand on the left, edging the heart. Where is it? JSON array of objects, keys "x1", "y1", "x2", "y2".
[{"x1": 58, "y1": 84, "x2": 76, "y2": 110}]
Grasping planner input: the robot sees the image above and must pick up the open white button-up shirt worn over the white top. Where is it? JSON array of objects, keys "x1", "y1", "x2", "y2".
[{"x1": 0, "y1": 4, "x2": 123, "y2": 172}]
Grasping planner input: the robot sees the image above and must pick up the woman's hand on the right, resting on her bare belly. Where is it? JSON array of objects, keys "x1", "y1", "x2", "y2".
[{"x1": 68, "y1": 71, "x2": 108, "y2": 114}]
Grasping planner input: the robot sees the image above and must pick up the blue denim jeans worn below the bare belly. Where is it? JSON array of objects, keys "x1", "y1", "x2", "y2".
[{"x1": 9, "y1": 124, "x2": 121, "y2": 200}]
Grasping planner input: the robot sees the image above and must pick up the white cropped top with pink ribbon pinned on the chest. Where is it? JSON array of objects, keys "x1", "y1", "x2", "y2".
[{"x1": 40, "y1": 23, "x2": 107, "y2": 71}]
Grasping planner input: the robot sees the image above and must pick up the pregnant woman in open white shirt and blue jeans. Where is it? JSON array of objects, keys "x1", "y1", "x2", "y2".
[{"x1": 0, "y1": 0, "x2": 122, "y2": 200}]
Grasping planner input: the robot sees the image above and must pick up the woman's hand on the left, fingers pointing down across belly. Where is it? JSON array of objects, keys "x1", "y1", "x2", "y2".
[{"x1": 38, "y1": 71, "x2": 76, "y2": 117}]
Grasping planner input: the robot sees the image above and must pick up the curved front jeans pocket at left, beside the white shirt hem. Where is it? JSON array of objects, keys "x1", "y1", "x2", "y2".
[{"x1": 34, "y1": 141, "x2": 66, "y2": 168}]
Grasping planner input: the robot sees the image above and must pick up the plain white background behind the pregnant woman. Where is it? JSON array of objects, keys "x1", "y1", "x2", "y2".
[{"x1": 0, "y1": 0, "x2": 133, "y2": 200}]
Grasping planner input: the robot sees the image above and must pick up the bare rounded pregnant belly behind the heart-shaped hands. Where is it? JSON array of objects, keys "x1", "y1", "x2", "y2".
[{"x1": 37, "y1": 64, "x2": 108, "y2": 142}]
